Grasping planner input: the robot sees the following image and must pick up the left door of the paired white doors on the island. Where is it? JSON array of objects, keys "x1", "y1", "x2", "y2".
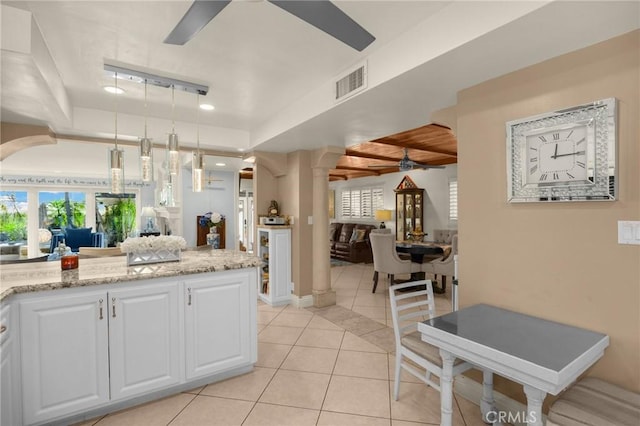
[{"x1": 19, "y1": 291, "x2": 109, "y2": 424}]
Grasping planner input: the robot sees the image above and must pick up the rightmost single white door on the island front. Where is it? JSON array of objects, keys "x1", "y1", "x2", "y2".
[{"x1": 184, "y1": 273, "x2": 257, "y2": 380}]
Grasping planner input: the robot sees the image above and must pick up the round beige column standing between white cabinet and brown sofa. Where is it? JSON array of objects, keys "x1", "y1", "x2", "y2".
[{"x1": 311, "y1": 167, "x2": 336, "y2": 308}]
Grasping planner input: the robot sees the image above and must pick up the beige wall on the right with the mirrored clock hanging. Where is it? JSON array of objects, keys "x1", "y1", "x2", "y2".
[{"x1": 457, "y1": 31, "x2": 640, "y2": 401}]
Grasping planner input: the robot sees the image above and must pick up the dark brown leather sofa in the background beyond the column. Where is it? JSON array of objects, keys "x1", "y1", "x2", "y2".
[{"x1": 329, "y1": 222, "x2": 376, "y2": 263}]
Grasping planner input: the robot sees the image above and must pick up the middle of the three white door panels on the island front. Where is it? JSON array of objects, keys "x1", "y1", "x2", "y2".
[{"x1": 108, "y1": 282, "x2": 181, "y2": 400}]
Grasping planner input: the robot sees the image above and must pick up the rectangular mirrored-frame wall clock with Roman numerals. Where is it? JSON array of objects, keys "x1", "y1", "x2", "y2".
[{"x1": 506, "y1": 98, "x2": 617, "y2": 202}]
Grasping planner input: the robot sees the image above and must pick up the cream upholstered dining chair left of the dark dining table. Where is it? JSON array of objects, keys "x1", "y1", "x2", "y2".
[{"x1": 369, "y1": 230, "x2": 421, "y2": 293}]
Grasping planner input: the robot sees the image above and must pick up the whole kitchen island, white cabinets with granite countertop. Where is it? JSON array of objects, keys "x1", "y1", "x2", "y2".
[{"x1": 0, "y1": 250, "x2": 260, "y2": 425}]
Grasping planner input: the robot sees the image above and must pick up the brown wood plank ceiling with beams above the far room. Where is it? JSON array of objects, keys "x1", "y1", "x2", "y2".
[{"x1": 329, "y1": 124, "x2": 458, "y2": 181}]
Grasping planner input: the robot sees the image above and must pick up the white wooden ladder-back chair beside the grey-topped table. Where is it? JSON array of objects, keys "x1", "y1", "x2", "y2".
[{"x1": 389, "y1": 280, "x2": 473, "y2": 401}]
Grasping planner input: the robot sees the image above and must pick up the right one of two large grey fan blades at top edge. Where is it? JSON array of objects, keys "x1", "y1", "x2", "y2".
[{"x1": 269, "y1": 0, "x2": 376, "y2": 52}]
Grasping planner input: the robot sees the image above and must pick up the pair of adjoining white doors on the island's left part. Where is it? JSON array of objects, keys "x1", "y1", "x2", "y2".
[{"x1": 20, "y1": 283, "x2": 181, "y2": 424}]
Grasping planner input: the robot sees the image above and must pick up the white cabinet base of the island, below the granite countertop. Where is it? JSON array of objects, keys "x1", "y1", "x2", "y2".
[{"x1": 7, "y1": 268, "x2": 257, "y2": 425}]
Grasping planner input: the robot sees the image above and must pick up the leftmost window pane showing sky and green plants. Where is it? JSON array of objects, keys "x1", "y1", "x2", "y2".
[{"x1": 0, "y1": 191, "x2": 27, "y2": 243}]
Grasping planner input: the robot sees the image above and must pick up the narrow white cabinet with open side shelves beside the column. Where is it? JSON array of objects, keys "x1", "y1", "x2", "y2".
[{"x1": 258, "y1": 226, "x2": 292, "y2": 305}]
